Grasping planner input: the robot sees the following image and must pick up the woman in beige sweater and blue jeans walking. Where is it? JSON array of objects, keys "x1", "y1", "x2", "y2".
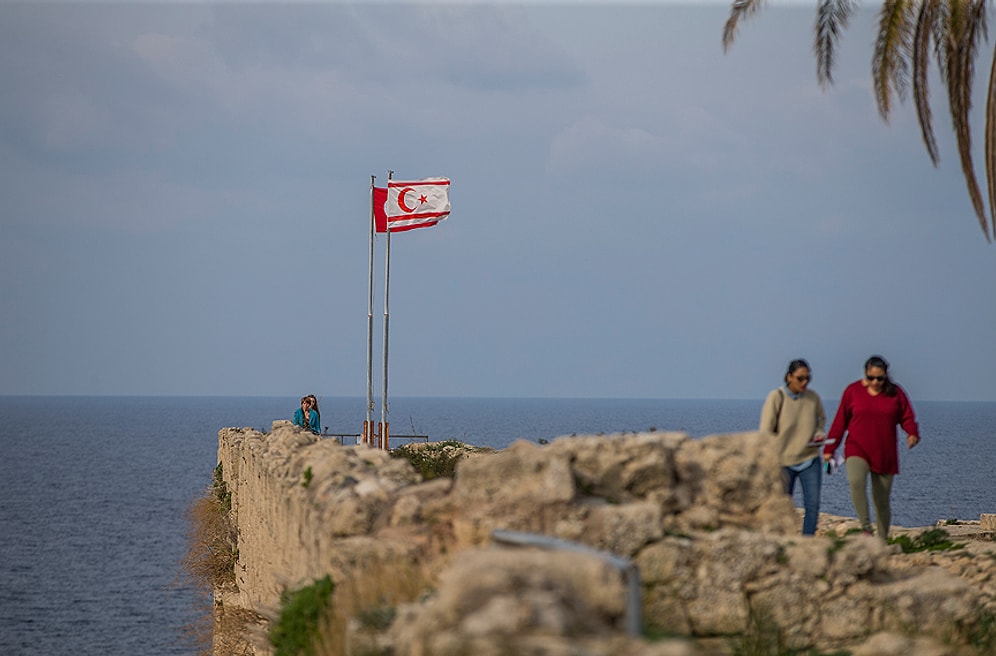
[{"x1": 760, "y1": 359, "x2": 827, "y2": 535}]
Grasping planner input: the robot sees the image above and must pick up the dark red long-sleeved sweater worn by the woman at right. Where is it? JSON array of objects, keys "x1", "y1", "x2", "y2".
[{"x1": 823, "y1": 380, "x2": 920, "y2": 474}]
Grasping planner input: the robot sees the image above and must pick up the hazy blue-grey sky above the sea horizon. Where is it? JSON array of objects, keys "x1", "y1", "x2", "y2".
[{"x1": 0, "y1": 2, "x2": 996, "y2": 407}]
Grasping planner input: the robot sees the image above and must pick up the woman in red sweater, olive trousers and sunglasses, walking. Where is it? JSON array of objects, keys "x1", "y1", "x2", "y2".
[{"x1": 823, "y1": 355, "x2": 920, "y2": 541}]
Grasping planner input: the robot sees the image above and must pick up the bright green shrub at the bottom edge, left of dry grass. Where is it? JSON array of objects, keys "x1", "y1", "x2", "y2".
[{"x1": 270, "y1": 575, "x2": 335, "y2": 656}]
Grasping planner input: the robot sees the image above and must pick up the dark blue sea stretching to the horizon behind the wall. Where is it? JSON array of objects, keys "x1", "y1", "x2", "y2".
[{"x1": 0, "y1": 396, "x2": 996, "y2": 656}]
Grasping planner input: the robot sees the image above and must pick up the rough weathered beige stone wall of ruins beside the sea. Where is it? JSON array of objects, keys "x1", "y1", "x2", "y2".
[{"x1": 216, "y1": 421, "x2": 996, "y2": 656}]
